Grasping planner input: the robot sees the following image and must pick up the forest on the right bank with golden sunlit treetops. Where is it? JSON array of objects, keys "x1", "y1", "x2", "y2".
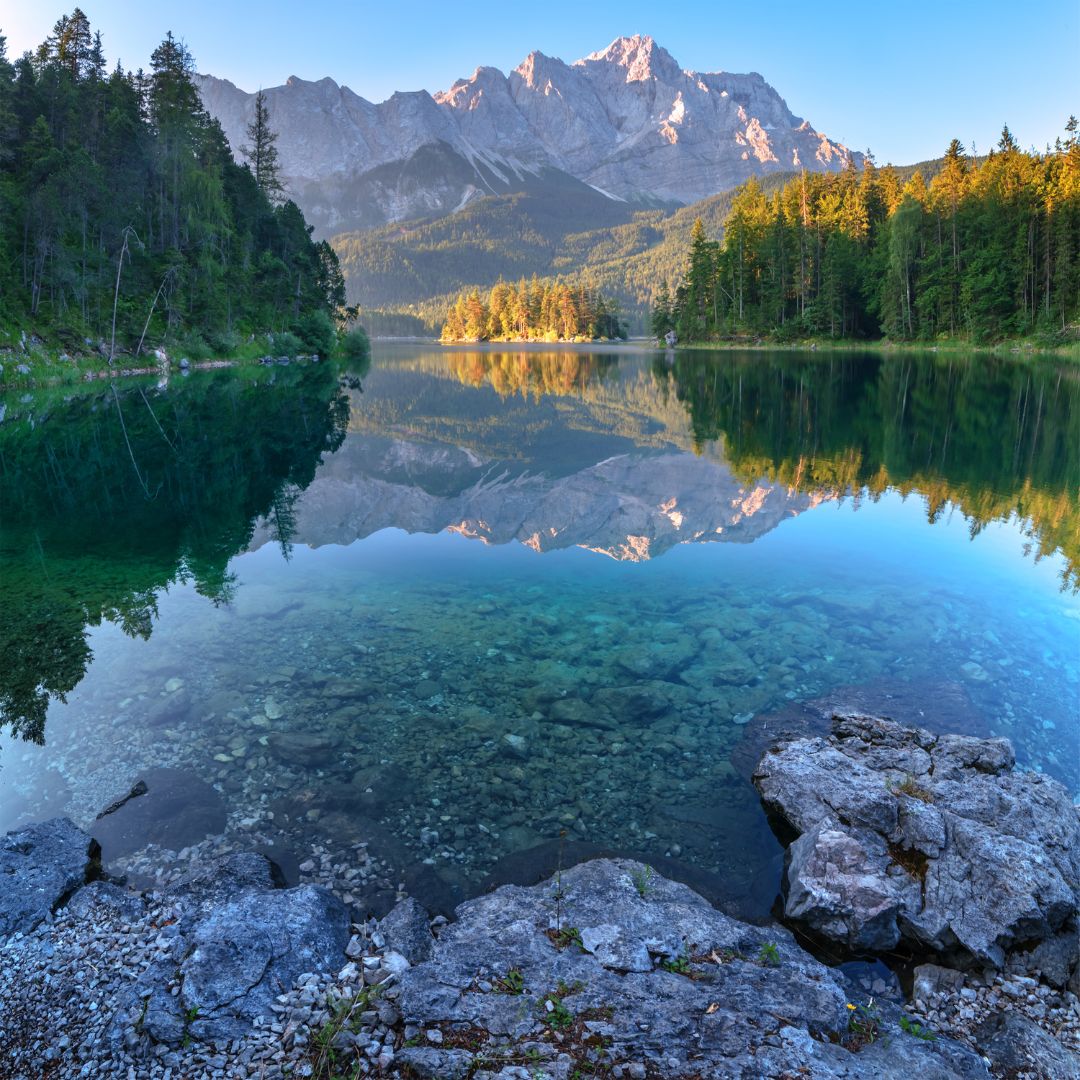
[{"x1": 652, "y1": 127, "x2": 1080, "y2": 342}]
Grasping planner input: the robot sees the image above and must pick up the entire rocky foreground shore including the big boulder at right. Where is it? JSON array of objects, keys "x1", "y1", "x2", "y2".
[{"x1": 0, "y1": 716, "x2": 1080, "y2": 1080}]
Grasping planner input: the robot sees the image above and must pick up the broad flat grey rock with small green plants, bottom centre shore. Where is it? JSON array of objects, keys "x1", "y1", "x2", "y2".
[{"x1": 396, "y1": 859, "x2": 987, "y2": 1080}]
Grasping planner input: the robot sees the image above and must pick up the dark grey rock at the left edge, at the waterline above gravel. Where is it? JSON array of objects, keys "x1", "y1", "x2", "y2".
[{"x1": 0, "y1": 818, "x2": 100, "y2": 939}]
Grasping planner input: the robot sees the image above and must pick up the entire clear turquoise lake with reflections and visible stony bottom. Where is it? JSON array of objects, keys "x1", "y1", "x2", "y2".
[{"x1": 0, "y1": 343, "x2": 1080, "y2": 917}]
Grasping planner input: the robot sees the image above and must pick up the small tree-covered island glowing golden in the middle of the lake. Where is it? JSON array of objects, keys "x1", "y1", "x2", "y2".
[{"x1": 442, "y1": 278, "x2": 625, "y2": 342}]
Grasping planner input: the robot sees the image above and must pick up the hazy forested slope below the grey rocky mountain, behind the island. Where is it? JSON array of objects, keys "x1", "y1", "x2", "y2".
[{"x1": 330, "y1": 160, "x2": 941, "y2": 335}]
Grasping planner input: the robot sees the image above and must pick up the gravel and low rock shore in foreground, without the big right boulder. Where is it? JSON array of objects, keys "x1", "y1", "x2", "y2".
[{"x1": 0, "y1": 820, "x2": 1080, "y2": 1080}]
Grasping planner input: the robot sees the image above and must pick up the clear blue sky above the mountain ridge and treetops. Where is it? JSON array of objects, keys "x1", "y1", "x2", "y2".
[{"x1": 0, "y1": 0, "x2": 1080, "y2": 164}]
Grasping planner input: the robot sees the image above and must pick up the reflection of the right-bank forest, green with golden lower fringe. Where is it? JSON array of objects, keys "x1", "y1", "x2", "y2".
[{"x1": 653, "y1": 352, "x2": 1080, "y2": 590}]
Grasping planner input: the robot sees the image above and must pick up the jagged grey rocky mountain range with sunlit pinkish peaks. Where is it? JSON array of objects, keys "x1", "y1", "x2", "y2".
[{"x1": 198, "y1": 36, "x2": 852, "y2": 235}]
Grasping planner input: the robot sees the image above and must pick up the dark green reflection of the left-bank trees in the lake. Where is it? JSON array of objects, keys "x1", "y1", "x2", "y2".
[{"x1": 0, "y1": 365, "x2": 348, "y2": 743}]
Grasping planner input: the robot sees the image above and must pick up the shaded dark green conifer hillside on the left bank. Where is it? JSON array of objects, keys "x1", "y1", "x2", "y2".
[{"x1": 0, "y1": 8, "x2": 345, "y2": 357}]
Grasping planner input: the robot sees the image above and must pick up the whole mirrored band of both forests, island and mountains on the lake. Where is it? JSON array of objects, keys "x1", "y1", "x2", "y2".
[{"x1": 0, "y1": 347, "x2": 1080, "y2": 742}]
